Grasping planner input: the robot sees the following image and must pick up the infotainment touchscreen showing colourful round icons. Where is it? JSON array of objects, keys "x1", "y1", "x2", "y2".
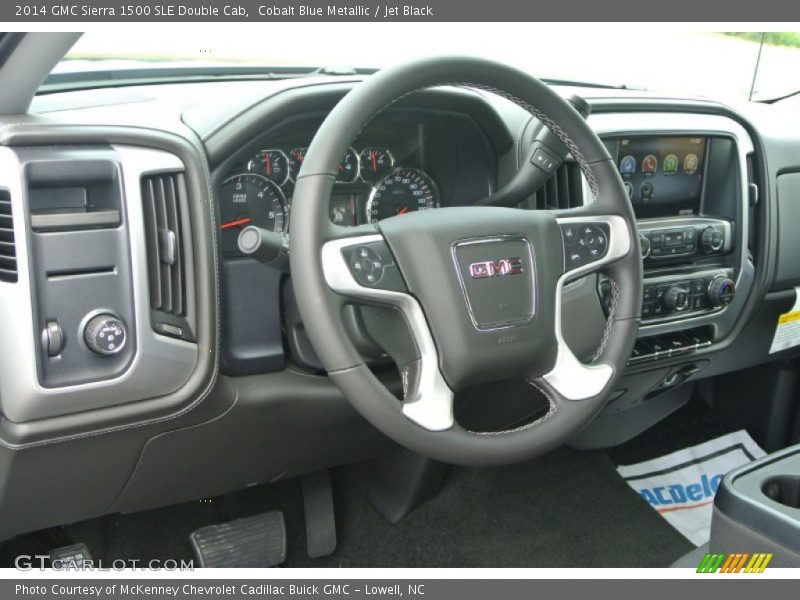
[{"x1": 617, "y1": 137, "x2": 707, "y2": 218}]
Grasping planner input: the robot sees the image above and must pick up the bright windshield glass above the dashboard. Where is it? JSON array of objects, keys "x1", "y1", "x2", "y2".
[{"x1": 51, "y1": 23, "x2": 800, "y2": 100}]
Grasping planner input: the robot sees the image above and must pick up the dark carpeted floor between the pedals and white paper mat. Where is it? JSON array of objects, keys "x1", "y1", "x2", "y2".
[{"x1": 288, "y1": 449, "x2": 692, "y2": 567}]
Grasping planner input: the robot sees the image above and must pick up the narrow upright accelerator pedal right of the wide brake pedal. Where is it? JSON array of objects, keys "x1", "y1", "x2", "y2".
[{"x1": 300, "y1": 471, "x2": 336, "y2": 558}]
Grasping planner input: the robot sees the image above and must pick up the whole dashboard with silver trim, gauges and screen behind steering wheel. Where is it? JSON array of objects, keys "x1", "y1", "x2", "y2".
[{"x1": 0, "y1": 69, "x2": 800, "y2": 535}]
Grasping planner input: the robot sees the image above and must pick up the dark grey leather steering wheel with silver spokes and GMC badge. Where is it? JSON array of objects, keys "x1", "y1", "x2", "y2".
[{"x1": 290, "y1": 57, "x2": 642, "y2": 465}]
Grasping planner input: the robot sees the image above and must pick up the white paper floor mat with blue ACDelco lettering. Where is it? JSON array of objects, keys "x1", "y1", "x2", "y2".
[{"x1": 618, "y1": 430, "x2": 764, "y2": 546}]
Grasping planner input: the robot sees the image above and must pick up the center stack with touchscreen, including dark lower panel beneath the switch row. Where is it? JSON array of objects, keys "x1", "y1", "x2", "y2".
[{"x1": 570, "y1": 110, "x2": 757, "y2": 449}]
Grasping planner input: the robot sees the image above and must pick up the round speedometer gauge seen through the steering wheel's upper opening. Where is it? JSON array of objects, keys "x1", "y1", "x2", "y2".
[{"x1": 367, "y1": 169, "x2": 440, "y2": 223}]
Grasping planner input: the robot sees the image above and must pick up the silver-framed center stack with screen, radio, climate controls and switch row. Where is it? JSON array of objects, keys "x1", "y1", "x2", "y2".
[{"x1": 592, "y1": 114, "x2": 752, "y2": 365}]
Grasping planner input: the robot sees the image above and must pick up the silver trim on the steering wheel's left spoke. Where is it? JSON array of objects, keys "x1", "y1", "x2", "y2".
[{"x1": 321, "y1": 234, "x2": 454, "y2": 431}]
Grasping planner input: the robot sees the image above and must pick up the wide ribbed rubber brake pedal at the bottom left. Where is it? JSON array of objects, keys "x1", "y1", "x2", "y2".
[{"x1": 189, "y1": 510, "x2": 286, "y2": 568}]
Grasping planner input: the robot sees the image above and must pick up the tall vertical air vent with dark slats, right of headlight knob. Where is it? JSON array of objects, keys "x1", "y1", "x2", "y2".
[{"x1": 142, "y1": 173, "x2": 186, "y2": 317}]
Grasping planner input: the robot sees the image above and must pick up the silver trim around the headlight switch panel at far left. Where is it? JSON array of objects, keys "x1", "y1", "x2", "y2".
[{"x1": 0, "y1": 146, "x2": 198, "y2": 422}]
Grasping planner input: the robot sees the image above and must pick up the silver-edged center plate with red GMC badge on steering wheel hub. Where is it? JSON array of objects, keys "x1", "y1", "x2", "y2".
[{"x1": 452, "y1": 236, "x2": 536, "y2": 331}]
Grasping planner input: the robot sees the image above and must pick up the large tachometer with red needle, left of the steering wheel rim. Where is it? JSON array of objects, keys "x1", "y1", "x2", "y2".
[{"x1": 219, "y1": 173, "x2": 286, "y2": 252}]
